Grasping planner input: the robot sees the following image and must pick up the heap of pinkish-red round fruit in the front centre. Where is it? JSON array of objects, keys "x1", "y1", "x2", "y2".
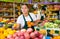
[{"x1": 6, "y1": 28, "x2": 43, "y2": 39}]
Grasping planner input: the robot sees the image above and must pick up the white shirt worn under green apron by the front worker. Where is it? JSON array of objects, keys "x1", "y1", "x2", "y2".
[{"x1": 17, "y1": 13, "x2": 37, "y2": 28}]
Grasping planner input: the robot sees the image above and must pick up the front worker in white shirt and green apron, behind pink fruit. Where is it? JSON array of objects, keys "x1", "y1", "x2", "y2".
[{"x1": 14, "y1": 4, "x2": 37, "y2": 29}]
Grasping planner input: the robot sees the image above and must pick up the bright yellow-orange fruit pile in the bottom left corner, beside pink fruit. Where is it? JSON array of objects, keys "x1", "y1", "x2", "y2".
[{"x1": 0, "y1": 27, "x2": 16, "y2": 39}]
